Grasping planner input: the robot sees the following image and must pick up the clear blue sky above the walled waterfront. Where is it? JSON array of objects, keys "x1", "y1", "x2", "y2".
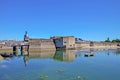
[{"x1": 0, "y1": 0, "x2": 120, "y2": 41}]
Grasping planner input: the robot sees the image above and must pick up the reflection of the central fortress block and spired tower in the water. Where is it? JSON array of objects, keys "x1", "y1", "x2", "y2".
[{"x1": 22, "y1": 50, "x2": 76, "y2": 66}]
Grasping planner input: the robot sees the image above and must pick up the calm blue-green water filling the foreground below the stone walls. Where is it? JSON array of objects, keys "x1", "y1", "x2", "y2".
[{"x1": 0, "y1": 50, "x2": 120, "y2": 80}]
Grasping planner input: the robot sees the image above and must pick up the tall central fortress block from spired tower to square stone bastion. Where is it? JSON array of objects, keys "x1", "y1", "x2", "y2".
[{"x1": 24, "y1": 32, "x2": 75, "y2": 49}]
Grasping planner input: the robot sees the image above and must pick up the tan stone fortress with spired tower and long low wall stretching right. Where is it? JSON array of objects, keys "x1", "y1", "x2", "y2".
[{"x1": 24, "y1": 32, "x2": 119, "y2": 51}]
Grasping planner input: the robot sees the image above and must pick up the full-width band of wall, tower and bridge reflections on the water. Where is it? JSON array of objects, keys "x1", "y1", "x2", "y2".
[{"x1": 0, "y1": 48, "x2": 120, "y2": 66}]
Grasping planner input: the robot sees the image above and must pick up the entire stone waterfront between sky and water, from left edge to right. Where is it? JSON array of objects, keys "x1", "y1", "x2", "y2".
[{"x1": 0, "y1": 32, "x2": 120, "y2": 53}]
